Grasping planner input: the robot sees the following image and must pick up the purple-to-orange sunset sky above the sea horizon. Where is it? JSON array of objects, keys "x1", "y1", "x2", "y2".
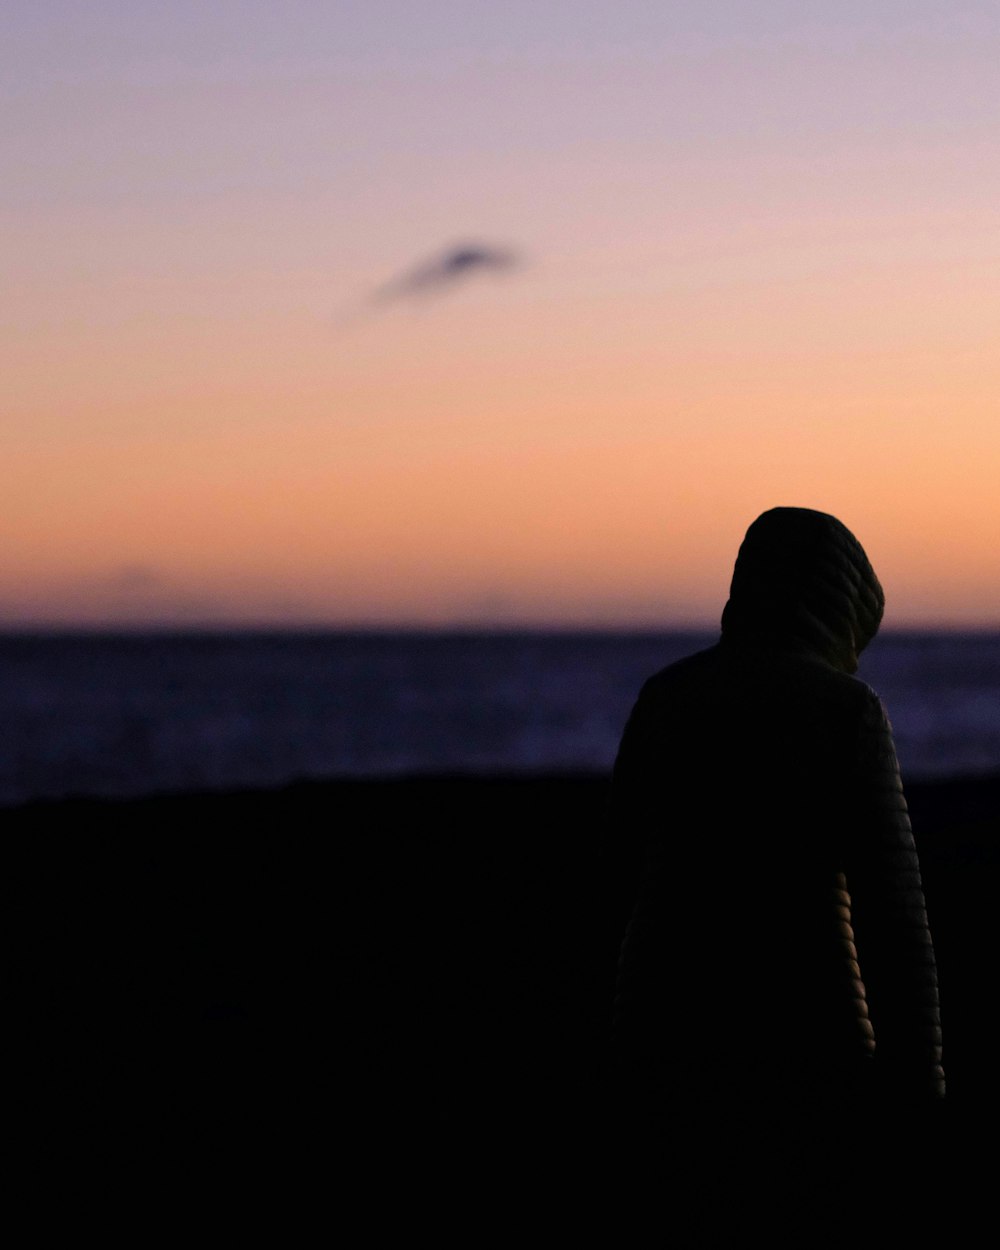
[{"x1": 7, "y1": 0, "x2": 1000, "y2": 628}]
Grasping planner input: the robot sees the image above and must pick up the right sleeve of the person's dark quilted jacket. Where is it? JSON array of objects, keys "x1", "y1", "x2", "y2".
[{"x1": 845, "y1": 691, "x2": 945, "y2": 1101}]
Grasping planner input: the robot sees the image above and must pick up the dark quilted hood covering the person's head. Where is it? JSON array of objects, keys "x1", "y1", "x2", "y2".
[{"x1": 723, "y1": 508, "x2": 885, "y2": 673}]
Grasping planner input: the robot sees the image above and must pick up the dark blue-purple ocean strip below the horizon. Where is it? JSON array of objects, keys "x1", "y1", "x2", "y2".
[{"x1": 0, "y1": 631, "x2": 1000, "y2": 806}]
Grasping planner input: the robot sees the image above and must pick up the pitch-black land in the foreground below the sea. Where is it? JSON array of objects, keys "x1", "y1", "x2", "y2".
[{"x1": 7, "y1": 776, "x2": 1000, "y2": 1230}]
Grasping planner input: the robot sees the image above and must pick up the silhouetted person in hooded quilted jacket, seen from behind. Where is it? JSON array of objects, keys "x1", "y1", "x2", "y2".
[{"x1": 604, "y1": 508, "x2": 944, "y2": 1244}]
